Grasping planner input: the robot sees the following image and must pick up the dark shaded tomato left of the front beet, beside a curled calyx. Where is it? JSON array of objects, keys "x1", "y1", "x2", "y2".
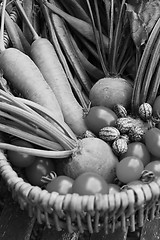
[{"x1": 25, "y1": 157, "x2": 55, "y2": 186}]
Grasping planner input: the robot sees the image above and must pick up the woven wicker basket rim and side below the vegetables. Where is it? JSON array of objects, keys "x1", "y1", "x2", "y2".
[{"x1": 0, "y1": 152, "x2": 160, "y2": 234}]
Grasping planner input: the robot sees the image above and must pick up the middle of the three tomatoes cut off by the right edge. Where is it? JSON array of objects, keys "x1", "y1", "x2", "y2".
[{"x1": 144, "y1": 127, "x2": 160, "y2": 158}]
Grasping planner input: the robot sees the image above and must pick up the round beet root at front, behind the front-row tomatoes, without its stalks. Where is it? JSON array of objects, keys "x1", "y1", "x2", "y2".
[{"x1": 63, "y1": 138, "x2": 118, "y2": 183}]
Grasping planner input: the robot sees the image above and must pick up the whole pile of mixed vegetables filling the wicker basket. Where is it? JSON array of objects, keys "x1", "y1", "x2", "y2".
[{"x1": 0, "y1": 0, "x2": 160, "y2": 213}]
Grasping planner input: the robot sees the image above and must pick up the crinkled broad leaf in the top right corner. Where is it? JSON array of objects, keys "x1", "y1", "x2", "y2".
[{"x1": 126, "y1": 0, "x2": 160, "y2": 48}]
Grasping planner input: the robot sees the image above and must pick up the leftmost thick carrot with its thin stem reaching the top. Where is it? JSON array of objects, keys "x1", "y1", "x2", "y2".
[{"x1": 0, "y1": 0, "x2": 64, "y2": 121}]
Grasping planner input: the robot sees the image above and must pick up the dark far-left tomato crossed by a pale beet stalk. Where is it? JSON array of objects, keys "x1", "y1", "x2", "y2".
[{"x1": 7, "y1": 138, "x2": 35, "y2": 168}]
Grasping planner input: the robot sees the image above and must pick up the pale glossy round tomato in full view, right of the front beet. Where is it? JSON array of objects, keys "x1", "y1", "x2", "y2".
[{"x1": 116, "y1": 156, "x2": 144, "y2": 183}]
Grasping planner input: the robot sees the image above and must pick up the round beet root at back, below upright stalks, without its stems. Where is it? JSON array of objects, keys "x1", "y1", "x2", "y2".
[{"x1": 89, "y1": 77, "x2": 133, "y2": 109}]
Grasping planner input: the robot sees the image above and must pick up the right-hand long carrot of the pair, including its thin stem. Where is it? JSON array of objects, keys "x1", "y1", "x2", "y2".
[{"x1": 16, "y1": 0, "x2": 87, "y2": 135}]
